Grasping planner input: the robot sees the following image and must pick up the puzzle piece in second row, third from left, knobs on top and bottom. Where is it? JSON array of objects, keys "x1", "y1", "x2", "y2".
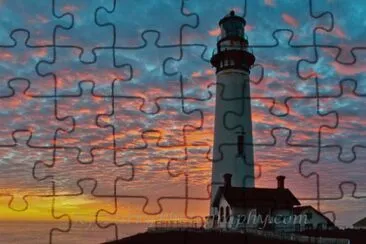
[{"x1": 114, "y1": 31, "x2": 186, "y2": 113}]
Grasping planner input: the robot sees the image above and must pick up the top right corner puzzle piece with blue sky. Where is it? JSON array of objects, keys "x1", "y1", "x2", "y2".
[{"x1": 311, "y1": 0, "x2": 366, "y2": 63}]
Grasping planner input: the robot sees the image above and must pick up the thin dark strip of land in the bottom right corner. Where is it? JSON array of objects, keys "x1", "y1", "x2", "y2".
[{"x1": 301, "y1": 229, "x2": 366, "y2": 244}]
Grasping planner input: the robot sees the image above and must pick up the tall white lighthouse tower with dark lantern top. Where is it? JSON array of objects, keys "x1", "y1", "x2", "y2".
[{"x1": 210, "y1": 11, "x2": 255, "y2": 215}]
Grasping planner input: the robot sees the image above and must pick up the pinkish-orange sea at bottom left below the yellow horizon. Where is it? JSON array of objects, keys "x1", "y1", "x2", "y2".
[{"x1": 0, "y1": 221, "x2": 149, "y2": 244}]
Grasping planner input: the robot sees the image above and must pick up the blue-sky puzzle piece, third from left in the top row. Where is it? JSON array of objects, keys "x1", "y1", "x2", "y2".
[{"x1": 96, "y1": 0, "x2": 198, "y2": 47}]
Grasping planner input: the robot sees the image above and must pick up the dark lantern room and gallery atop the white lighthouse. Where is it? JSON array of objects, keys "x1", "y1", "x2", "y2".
[{"x1": 211, "y1": 11, "x2": 255, "y2": 73}]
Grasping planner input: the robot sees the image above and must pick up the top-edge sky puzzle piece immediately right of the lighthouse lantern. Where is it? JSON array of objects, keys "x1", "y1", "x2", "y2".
[{"x1": 244, "y1": 0, "x2": 335, "y2": 45}]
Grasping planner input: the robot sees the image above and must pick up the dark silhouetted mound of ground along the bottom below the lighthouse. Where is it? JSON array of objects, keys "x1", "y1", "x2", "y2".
[{"x1": 102, "y1": 231, "x2": 308, "y2": 244}]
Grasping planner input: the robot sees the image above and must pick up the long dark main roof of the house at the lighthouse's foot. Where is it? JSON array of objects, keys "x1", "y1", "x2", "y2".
[{"x1": 212, "y1": 186, "x2": 300, "y2": 208}]
